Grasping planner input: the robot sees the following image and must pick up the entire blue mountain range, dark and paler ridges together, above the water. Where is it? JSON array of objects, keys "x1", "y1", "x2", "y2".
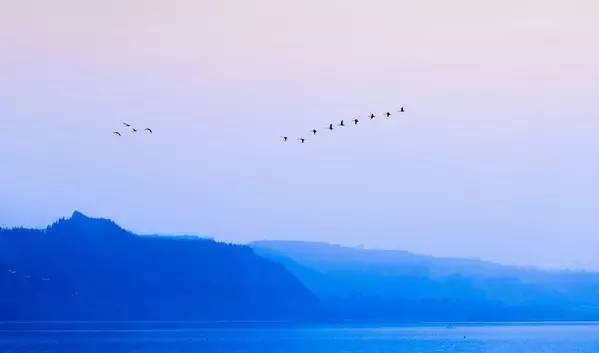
[{"x1": 0, "y1": 212, "x2": 599, "y2": 321}]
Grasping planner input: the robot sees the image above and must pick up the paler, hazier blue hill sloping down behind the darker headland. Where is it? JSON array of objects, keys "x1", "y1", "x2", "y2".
[{"x1": 252, "y1": 241, "x2": 599, "y2": 321}]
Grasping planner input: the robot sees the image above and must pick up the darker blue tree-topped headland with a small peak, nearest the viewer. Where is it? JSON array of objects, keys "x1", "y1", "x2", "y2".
[{"x1": 0, "y1": 212, "x2": 319, "y2": 320}]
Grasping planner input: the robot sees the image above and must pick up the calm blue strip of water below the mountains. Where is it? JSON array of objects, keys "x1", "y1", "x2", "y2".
[{"x1": 0, "y1": 322, "x2": 599, "y2": 353}]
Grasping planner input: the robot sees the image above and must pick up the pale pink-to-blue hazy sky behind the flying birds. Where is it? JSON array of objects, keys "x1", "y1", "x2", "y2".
[{"x1": 0, "y1": 0, "x2": 599, "y2": 270}]
